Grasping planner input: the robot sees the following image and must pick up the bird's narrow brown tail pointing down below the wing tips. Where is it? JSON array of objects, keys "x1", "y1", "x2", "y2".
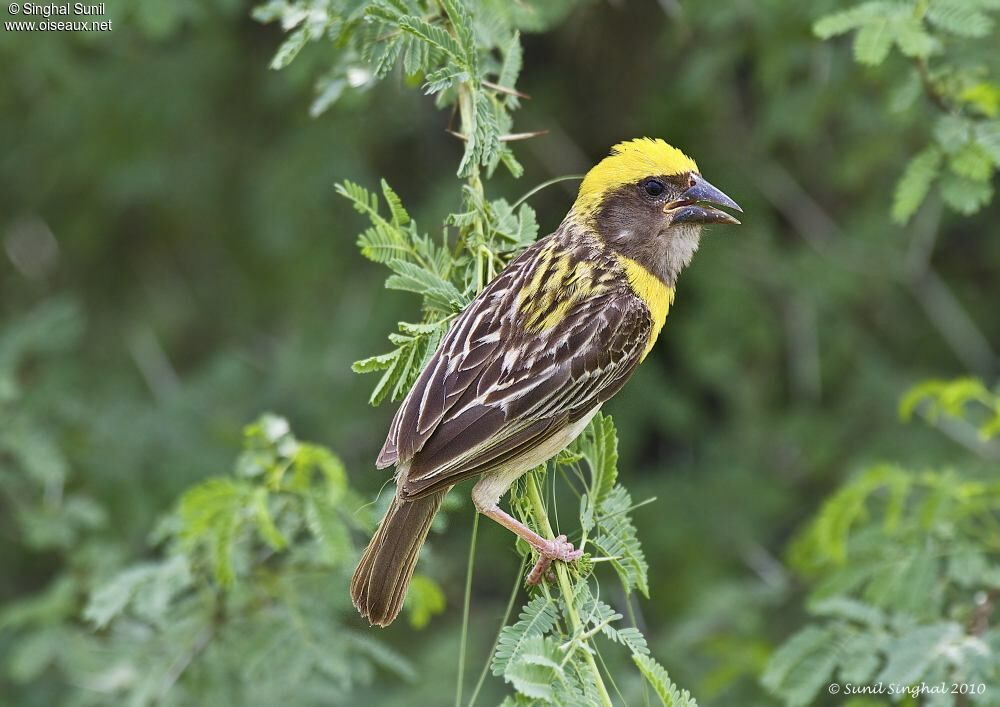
[{"x1": 351, "y1": 490, "x2": 448, "y2": 626}]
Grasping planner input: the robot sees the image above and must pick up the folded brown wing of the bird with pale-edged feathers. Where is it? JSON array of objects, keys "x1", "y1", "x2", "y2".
[{"x1": 402, "y1": 286, "x2": 650, "y2": 497}]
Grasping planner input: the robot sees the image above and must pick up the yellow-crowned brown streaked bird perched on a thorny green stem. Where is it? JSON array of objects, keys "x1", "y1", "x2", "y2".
[{"x1": 350, "y1": 138, "x2": 742, "y2": 626}]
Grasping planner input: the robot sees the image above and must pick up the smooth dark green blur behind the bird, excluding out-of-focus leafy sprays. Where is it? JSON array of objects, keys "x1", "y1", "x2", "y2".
[{"x1": 0, "y1": 0, "x2": 1000, "y2": 705}]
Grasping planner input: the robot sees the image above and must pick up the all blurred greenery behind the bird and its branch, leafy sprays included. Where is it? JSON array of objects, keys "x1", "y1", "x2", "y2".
[{"x1": 0, "y1": 0, "x2": 1000, "y2": 705}]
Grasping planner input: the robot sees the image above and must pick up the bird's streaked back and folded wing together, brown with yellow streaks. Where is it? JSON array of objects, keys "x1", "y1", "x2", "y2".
[{"x1": 378, "y1": 225, "x2": 651, "y2": 498}]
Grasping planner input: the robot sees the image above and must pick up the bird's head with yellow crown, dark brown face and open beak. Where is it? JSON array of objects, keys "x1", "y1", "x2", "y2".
[{"x1": 571, "y1": 138, "x2": 742, "y2": 286}]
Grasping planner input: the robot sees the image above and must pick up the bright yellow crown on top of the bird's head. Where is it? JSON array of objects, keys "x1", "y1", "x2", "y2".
[{"x1": 573, "y1": 137, "x2": 698, "y2": 216}]
